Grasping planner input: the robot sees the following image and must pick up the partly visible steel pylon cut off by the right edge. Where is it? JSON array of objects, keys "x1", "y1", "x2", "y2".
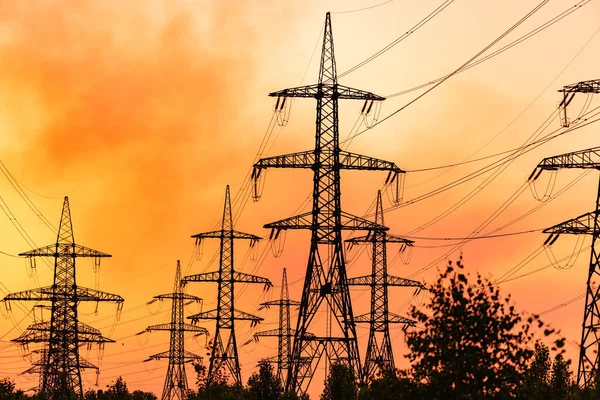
[{"x1": 529, "y1": 76, "x2": 600, "y2": 387}]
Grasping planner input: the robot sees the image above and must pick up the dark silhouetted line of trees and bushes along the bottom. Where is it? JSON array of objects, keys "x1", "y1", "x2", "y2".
[{"x1": 0, "y1": 260, "x2": 600, "y2": 400}]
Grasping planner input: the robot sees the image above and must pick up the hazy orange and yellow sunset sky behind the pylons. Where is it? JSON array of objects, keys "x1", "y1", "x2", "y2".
[{"x1": 0, "y1": 0, "x2": 600, "y2": 394}]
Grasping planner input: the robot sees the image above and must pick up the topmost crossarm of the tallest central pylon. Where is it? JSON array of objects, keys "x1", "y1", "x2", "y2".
[{"x1": 269, "y1": 83, "x2": 385, "y2": 101}]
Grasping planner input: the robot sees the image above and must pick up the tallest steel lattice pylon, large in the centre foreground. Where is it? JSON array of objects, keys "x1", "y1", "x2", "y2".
[{"x1": 252, "y1": 13, "x2": 404, "y2": 393}]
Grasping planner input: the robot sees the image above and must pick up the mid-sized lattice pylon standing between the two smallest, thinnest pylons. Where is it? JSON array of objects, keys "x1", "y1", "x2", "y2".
[{"x1": 182, "y1": 186, "x2": 272, "y2": 385}]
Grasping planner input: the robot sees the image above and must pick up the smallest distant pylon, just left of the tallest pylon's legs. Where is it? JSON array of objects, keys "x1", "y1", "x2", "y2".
[{"x1": 254, "y1": 268, "x2": 300, "y2": 381}]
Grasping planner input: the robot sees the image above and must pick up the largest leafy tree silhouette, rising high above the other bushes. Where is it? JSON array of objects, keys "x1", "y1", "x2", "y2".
[{"x1": 407, "y1": 257, "x2": 560, "y2": 400}]
